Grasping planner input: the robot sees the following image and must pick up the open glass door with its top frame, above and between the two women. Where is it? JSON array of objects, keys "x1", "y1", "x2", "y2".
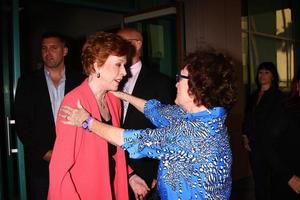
[{"x1": 124, "y1": 4, "x2": 184, "y2": 78}]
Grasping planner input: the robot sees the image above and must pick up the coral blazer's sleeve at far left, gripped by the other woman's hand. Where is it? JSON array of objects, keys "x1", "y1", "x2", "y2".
[{"x1": 48, "y1": 101, "x2": 84, "y2": 200}]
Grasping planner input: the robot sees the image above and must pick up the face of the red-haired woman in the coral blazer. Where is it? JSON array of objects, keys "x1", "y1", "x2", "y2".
[{"x1": 94, "y1": 55, "x2": 126, "y2": 91}]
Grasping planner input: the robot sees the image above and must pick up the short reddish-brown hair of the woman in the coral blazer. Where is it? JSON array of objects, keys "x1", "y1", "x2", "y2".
[{"x1": 81, "y1": 32, "x2": 135, "y2": 75}]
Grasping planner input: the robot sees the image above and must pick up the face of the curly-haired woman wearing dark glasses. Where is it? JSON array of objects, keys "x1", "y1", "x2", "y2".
[{"x1": 175, "y1": 67, "x2": 193, "y2": 110}]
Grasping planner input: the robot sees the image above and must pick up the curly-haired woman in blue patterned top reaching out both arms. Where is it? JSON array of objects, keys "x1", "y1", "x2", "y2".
[{"x1": 60, "y1": 51, "x2": 235, "y2": 200}]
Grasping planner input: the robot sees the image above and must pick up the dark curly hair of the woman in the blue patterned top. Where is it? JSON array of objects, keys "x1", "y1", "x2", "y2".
[{"x1": 183, "y1": 50, "x2": 236, "y2": 110}]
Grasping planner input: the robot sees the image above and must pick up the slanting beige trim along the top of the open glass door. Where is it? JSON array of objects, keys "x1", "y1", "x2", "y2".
[{"x1": 124, "y1": 7, "x2": 176, "y2": 24}]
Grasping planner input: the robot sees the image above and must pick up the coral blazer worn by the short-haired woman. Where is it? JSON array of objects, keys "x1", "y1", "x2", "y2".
[{"x1": 48, "y1": 79, "x2": 128, "y2": 200}]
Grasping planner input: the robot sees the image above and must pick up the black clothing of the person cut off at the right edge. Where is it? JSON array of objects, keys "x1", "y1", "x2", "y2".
[{"x1": 264, "y1": 96, "x2": 300, "y2": 200}]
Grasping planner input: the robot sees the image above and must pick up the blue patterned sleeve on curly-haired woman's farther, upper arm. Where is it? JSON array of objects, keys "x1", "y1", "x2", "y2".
[{"x1": 144, "y1": 99, "x2": 186, "y2": 127}]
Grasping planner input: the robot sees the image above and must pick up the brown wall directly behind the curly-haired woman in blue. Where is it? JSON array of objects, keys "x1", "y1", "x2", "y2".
[{"x1": 183, "y1": 0, "x2": 250, "y2": 179}]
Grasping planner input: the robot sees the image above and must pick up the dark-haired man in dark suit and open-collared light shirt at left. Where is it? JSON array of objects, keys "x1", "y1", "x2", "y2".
[{"x1": 15, "y1": 33, "x2": 84, "y2": 200}]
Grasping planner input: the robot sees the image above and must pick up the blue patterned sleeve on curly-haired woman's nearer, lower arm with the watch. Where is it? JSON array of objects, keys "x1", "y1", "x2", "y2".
[{"x1": 122, "y1": 122, "x2": 200, "y2": 161}]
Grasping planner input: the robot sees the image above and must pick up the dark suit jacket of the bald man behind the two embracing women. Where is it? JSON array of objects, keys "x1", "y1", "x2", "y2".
[{"x1": 123, "y1": 65, "x2": 175, "y2": 186}]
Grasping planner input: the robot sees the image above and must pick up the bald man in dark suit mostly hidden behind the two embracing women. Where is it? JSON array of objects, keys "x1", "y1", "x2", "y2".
[{"x1": 118, "y1": 27, "x2": 175, "y2": 199}]
